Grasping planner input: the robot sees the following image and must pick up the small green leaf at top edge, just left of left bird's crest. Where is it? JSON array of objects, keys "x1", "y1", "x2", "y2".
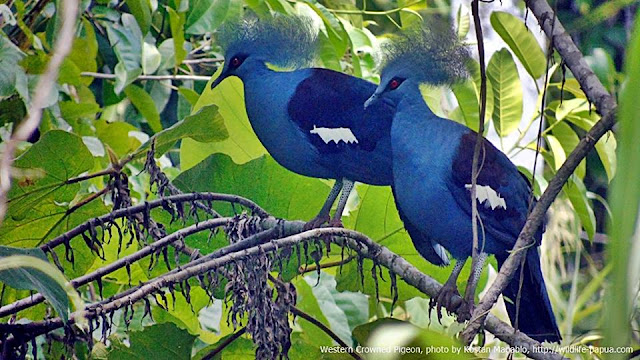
[{"x1": 185, "y1": 0, "x2": 231, "y2": 35}]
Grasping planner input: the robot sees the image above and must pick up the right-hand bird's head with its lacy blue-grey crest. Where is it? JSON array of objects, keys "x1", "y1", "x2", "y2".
[{"x1": 365, "y1": 22, "x2": 469, "y2": 107}]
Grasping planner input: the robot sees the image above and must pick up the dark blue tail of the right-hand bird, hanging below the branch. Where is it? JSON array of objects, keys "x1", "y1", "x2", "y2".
[{"x1": 496, "y1": 247, "x2": 562, "y2": 342}]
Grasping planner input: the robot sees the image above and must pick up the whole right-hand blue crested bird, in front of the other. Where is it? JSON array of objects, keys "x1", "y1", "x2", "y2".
[{"x1": 365, "y1": 28, "x2": 561, "y2": 342}]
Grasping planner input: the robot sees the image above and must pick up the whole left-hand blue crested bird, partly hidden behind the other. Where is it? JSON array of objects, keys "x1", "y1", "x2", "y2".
[{"x1": 212, "y1": 16, "x2": 392, "y2": 227}]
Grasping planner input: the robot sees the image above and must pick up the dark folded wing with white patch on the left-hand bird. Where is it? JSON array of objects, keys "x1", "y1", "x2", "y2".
[{"x1": 287, "y1": 69, "x2": 393, "y2": 154}]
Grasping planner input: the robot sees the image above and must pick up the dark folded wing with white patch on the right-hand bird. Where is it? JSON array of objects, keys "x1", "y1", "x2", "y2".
[{"x1": 448, "y1": 131, "x2": 542, "y2": 245}]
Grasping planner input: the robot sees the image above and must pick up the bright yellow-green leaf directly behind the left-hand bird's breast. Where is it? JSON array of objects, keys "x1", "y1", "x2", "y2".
[{"x1": 180, "y1": 74, "x2": 267, "y2": 170}]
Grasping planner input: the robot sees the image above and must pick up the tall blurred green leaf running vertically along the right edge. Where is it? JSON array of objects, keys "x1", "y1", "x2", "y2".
[{"x1": 601, "y1": 15, "x2": 640, "y2": 354}]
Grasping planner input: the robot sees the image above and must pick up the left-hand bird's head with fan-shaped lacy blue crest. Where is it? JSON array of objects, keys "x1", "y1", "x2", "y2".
[{"x1": 211, "y1": 14, "x2": 317, "y2": 88}]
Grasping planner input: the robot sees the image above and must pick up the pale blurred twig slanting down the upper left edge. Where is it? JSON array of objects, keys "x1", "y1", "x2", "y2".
[{"x1": 0, "y1": 0, "x2": 78, "y2": 225}]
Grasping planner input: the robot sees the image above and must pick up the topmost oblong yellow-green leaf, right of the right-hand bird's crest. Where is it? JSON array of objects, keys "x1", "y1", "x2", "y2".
[{"x1": 491, "y1": 11, "x2": 547, "y2": 79}]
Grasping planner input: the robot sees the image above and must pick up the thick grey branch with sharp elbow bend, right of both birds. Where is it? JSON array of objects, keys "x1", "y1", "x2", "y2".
[{"x1": 461, "y1": 0, "x2": 616, "y2": 343}]
